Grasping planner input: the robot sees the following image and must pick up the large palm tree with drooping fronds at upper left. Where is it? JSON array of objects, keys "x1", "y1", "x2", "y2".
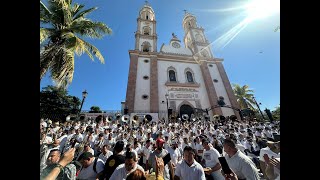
[{"x1": 40, "y1": 0, "x2": 112, "y2": 87}]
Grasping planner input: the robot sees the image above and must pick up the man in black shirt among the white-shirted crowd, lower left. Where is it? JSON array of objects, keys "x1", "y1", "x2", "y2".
[{"x1": 100, "y1": 140, "x2": 125, "y2": 179}]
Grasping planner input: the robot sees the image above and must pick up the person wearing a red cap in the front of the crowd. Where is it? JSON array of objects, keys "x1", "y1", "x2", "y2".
[{"x1": 147, "y1": 138, "x2": 171, "y2": 180}]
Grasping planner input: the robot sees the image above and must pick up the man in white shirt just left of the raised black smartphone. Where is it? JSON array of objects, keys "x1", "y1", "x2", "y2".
[{"x1": 202, "y1": 140, "x2": 225, "y2": 180}]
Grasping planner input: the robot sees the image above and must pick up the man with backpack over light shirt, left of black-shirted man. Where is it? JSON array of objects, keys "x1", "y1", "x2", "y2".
[{"x1": 77, "y1": 152, "x2": 104, "y2": 180}]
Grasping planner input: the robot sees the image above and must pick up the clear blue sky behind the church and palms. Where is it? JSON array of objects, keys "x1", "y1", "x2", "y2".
[{"x1": 40, "y1": 0, "x2": 280, "y2": 110}]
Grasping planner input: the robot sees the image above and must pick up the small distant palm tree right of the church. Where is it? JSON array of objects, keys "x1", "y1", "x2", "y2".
[{"x1": 232, "y1": 84, "x2": 256, "y2": 110}]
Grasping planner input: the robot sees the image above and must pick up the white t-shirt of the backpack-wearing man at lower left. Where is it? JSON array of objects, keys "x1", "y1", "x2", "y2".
[{"x1": 77, "y1": 159, "x2": 104, "y2": 180}]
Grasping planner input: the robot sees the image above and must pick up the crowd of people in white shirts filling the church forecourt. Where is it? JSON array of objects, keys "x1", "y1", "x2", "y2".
[{"x1": 40, "y1": 115, "x2": 280, "y2": 180}]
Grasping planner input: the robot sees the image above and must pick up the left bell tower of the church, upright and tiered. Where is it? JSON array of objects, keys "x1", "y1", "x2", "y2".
[{"x1": 135, "y1": 1, "x2": 157, "y2": 52}]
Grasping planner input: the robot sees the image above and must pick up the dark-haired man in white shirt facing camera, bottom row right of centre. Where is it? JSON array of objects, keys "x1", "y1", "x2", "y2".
[{"x1": 174, "y1": 146, "x2": 206, "y2": 180}]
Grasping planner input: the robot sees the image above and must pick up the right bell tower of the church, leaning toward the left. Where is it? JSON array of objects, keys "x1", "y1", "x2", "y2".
[{"x1": 182, "y1": 10, "x2": 214, "y2": 59}]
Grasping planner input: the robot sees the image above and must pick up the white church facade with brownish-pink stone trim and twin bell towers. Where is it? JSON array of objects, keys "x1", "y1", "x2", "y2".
[{"x1": 124, "y1": 4, "x2": 240, "y2": 119}]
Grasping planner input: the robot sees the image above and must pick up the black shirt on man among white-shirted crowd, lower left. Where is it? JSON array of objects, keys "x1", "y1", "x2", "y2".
[{"x1": 103, "y1": 154, "x2": 125, "y2": 180}]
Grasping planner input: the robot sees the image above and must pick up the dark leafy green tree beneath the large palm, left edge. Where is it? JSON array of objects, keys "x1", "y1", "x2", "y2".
[{"x1": 40, "y1": 86, "x2": 81, "y2": 121}]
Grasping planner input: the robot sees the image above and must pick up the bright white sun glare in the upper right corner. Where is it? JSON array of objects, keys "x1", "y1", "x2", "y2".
[{"x1": 246, "y1": 0, "x2": 280, "y2": 21}]
